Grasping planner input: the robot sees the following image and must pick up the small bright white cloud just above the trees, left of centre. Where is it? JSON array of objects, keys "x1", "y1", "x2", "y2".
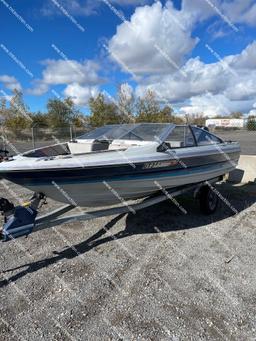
[{"x1": 64, "y1": 83, "x2": 99, "y2": 106}]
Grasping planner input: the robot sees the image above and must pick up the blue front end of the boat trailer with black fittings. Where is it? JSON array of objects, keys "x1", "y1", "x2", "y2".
[{"x1": 0, "y1": 193, "x2": 45, "y2": 241}]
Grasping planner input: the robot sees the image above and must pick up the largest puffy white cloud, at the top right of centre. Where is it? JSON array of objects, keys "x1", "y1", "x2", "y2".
[{"x1": 109, "y1": 1, "x2": 197, "y2": 74}]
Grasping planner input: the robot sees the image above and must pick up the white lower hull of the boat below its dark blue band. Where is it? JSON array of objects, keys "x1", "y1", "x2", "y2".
[{"x1": 21, "y1": 161, "x2": 234, "y2": 207}]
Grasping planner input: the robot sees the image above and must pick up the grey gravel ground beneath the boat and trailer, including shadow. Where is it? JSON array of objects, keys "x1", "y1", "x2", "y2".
[{"x1": 0, "y1": 184, "x2": 256, "y2": 341}]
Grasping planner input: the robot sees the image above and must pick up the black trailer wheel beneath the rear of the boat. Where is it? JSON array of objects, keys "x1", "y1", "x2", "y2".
[{"x1": 199, "y1": 186, "x2": 219, "y2": 215}]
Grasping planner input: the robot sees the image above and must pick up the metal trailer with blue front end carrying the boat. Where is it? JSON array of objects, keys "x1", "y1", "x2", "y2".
[{"x1": 0, "y1": 177, "x2": 222, "y2": 242}]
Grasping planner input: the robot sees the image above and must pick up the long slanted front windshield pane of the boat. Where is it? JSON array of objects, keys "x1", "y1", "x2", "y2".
[{"x1": 78, "y1": 123, "x2": 172, "y2": 141}]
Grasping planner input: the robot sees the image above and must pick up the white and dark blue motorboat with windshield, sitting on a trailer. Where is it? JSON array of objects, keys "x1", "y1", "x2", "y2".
[{"x1": 0, "y1": 123, "x2": 240, "y2": 207}]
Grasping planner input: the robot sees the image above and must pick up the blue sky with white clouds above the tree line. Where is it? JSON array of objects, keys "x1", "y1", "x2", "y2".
[{"x1": 0, "y1": 0, "x2": 256, "y2": 116}]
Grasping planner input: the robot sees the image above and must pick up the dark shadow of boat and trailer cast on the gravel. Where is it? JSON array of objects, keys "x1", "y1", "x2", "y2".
[{"x1": 0, "y1": 184, "x2": 256, "y2": 288}]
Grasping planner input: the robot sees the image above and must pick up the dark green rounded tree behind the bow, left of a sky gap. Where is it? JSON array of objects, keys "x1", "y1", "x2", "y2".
[{"x1": 47, "y1": 97, "x2": 78, "y2": 128}]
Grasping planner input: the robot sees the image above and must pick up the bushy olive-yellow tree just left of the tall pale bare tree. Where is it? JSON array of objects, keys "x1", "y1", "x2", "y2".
[{"x1": 89, "y1": 94, "x2": 119, "y2": 127}]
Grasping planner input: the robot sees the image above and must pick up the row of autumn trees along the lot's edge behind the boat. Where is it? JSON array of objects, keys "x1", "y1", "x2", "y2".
[{"x1": 0, "y1": 87, "x2": 256, "y2": 133}]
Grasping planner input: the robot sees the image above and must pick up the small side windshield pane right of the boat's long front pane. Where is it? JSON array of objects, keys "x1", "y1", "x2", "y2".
[{"x1": 165, "y1": 126, "x2": 195, "y2": 148}]
